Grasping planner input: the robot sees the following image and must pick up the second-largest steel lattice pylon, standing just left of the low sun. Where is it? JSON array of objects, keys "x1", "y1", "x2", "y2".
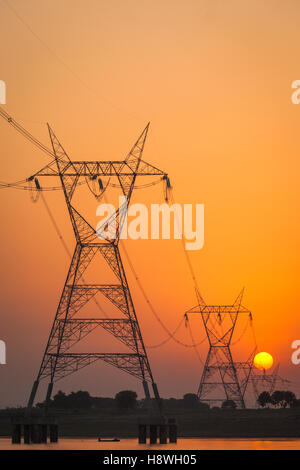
[{"x1": 187, "y1": 289, "x2": 252, "y2": 408}]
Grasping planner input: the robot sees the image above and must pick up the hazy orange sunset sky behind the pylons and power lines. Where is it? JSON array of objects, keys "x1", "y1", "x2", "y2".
[{"x1": 0, "y1": 0, "x2": 300, "y2": 406}]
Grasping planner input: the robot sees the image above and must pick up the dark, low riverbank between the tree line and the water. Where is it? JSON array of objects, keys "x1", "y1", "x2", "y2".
[{"x1": 0, "y1": 408, "x2": 300, "y2": 438}]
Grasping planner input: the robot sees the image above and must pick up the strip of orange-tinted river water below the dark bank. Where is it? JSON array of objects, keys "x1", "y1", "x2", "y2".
[{"x1": 0, "y1": 438, "x2": 300, "y2": 450}]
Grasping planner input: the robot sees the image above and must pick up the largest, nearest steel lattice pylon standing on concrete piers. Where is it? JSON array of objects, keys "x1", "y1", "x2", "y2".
[{"x1": 28, "y1": 124, "x2": 167, "y2": 410}]
